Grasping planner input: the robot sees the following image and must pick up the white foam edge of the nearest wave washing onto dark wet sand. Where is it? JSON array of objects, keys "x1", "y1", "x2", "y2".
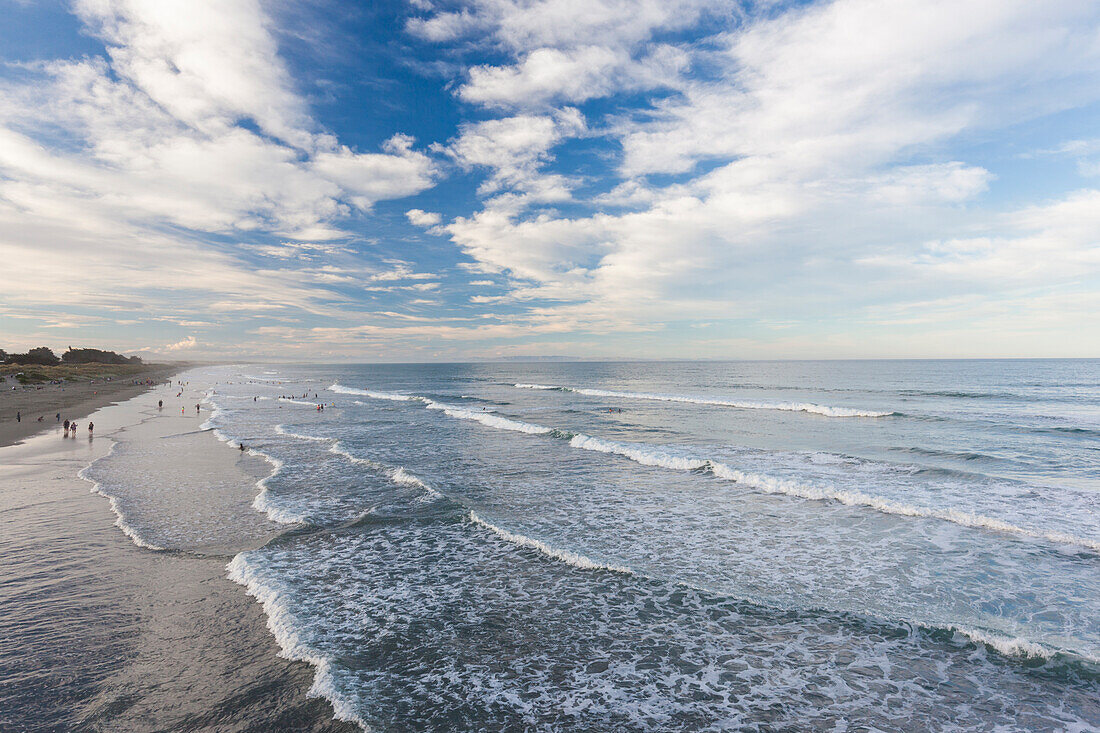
[{"x1": 226, "y1": 553, "x2": 370, "y2": 731}]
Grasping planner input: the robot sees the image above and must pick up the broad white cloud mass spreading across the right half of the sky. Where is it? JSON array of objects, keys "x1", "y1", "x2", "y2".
[{"x1": 415, "y1": 0, "x2": 1100, "y2": 349}]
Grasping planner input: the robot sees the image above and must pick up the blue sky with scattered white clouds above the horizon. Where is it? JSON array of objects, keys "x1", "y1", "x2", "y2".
[{"x1": 0, "y1": 0, "x2": 1100, "y2": 361}]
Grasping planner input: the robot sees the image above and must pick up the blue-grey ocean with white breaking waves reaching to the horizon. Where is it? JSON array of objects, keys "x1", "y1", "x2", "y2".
[{"x1": 86, "y1": 360, "x2": 1100, "y2": 731}]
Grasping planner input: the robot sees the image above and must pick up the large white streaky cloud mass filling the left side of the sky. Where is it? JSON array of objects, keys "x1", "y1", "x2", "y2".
[{"x1": 0, "y1": 0, "x2": 438, "y2": 348}]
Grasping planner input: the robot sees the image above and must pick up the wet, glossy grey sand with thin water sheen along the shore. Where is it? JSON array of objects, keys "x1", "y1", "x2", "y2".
[{"x1": 0, "y1": 374, "x2": 354, "y2": 731}]
